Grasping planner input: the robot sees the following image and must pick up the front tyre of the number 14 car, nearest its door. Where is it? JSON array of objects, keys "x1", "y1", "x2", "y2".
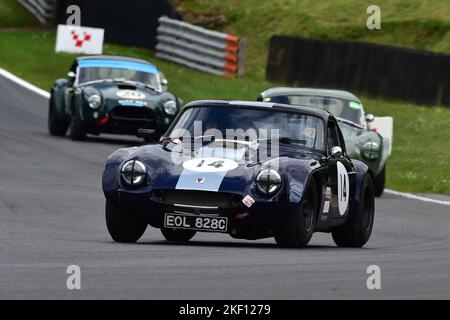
[{"x1": 274, "y1": 179, "x2": 318, "y2": 248}]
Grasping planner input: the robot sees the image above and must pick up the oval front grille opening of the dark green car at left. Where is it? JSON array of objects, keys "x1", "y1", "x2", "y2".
[{"x1": 111, "y1": 106, "x2": 155, "y2": 128}]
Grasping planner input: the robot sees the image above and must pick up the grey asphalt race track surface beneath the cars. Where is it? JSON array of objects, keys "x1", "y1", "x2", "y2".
[{"x1": 0, "y1": 77, "x2": 450, "y2": 299}]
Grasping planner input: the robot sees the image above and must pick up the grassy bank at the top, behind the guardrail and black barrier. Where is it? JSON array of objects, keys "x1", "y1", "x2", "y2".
[{"x1": 171, "y1": 0, "x2": 450, "y2": 78}]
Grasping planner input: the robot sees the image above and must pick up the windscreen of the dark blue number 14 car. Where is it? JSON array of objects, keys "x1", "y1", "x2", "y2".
[{"x1": 169, "y1": 106, "x2": 324, "y2": 151}]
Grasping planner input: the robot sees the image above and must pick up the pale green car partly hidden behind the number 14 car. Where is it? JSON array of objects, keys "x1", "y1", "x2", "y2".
[{"x1": 258, "y1": 87, "x2": 393, "y2": 196}]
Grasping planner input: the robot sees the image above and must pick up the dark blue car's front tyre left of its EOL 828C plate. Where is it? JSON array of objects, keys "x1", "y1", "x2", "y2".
[{"x1": 105, "y1": 200, "x2": 147, "y2": 243}]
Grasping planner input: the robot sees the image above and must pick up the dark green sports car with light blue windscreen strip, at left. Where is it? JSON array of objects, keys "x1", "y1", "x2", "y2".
[{"x1": 48, "y1": 55, "x2": 182, "y2": 140}]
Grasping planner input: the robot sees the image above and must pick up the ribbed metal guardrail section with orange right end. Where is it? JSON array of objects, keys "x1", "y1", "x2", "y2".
[{"x1": 156, "y1": 17, "x2": 244, "y2": 78}]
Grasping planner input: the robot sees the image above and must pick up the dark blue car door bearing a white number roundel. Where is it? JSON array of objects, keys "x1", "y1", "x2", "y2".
[{"x1": 327, "y1": 119, "x2": 353, "y2": 218}]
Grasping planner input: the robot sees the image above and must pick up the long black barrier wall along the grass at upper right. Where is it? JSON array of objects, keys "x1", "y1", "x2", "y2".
[{"x1": 266, "y1": 36, "x2": 450, "y2": 106}]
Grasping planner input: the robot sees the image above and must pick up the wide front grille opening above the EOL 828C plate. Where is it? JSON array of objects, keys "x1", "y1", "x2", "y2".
[{"x1": 152, "y1": 190, "x2": 242, "y2": 208}]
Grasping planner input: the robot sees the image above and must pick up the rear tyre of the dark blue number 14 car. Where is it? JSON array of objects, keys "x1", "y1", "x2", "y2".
[{"x1": 331, "y1": 174, "x2": 375, "y2": 248}]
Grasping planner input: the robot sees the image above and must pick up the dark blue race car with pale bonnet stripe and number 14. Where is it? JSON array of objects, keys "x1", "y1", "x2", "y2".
[{"x1": 103, "y1": 101, "x2": 374, "y2": 247}]
